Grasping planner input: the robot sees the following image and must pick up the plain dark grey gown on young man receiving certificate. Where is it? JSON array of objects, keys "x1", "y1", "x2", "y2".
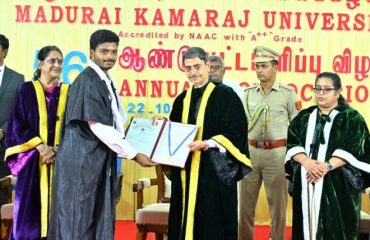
[{"x1": 48, "y1": 67, "x2": 116, "y2": 240}]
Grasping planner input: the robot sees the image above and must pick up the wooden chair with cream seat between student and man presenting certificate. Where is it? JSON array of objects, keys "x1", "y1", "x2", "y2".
[{"x1": 133, "y1": 165, "x2": 171, "y2": 240}]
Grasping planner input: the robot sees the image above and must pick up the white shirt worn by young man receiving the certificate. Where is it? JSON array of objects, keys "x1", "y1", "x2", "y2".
[{"x1": 88, "y1": 61, "x2": 138, "y2": 159}]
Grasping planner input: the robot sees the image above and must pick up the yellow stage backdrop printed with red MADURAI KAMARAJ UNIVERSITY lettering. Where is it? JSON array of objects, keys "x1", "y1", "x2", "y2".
[{"x1": 0, "y1": 0, "x2": 370, "y2": 224}]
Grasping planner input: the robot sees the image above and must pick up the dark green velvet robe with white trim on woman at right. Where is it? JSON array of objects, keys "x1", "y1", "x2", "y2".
[{"x1": 286, "y1": 106, "x2": 370, "y2": 240}]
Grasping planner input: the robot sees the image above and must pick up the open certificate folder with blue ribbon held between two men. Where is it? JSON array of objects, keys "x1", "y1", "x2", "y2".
[{"x1": 126, "y1": 117, "x2": 198, "y2": 168}]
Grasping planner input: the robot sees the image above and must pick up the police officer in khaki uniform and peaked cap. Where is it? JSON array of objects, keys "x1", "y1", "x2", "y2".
[{"x1": 239, "y1": 47, "x2": 301, "y2": 240}]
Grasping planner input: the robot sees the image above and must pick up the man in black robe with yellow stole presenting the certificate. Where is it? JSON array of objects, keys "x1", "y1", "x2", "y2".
[{"x1": 168, "y1": 47, "x2": 251, "y2": 240}]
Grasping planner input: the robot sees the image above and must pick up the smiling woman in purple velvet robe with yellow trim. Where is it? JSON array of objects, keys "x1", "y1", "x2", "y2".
[{"x1": 5, "y1": 46, "x2": 68, "y2": 239}]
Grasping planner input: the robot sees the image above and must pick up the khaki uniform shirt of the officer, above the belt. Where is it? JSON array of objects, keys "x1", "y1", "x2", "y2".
[{"x1": 243, "y1": 81, "x2": 300, "y2": 141}]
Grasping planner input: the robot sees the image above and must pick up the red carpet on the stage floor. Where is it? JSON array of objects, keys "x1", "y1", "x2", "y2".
[{"x1": 114, "y1": 221, "x2": 292, "y2": 240}]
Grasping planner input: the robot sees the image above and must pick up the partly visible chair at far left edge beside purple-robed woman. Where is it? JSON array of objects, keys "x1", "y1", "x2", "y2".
[{"x1": 0, "y1": 176, "x2": 13, "y2": 240}]
